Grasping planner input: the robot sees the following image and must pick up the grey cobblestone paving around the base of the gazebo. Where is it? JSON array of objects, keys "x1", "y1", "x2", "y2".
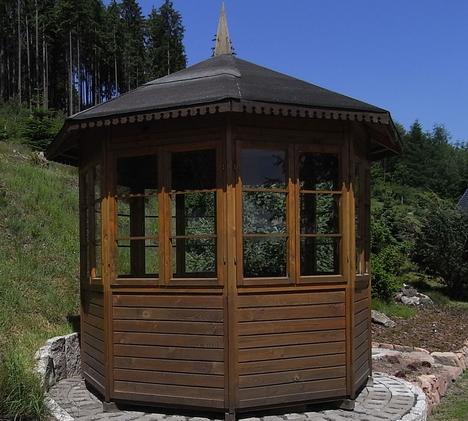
[{"x1": 49, "y1": 373, "x2": 426, "y2": 421}]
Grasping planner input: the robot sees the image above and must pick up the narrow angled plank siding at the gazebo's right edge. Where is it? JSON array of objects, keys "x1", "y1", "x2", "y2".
[{"x1": 352, "y1": 283, "x2": 371, "y2": 390}]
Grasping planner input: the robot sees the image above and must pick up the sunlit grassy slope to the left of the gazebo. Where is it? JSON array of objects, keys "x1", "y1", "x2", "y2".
[{"x1": 0, "y1": 142, "x2": 79, "y2": 419}]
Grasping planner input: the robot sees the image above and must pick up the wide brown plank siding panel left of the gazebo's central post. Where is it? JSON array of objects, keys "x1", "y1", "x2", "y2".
[{"x1": 112, "y1": 293, "x2": 224, "y2": 409}]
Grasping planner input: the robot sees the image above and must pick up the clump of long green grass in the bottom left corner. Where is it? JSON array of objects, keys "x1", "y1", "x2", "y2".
[{"x1": 0, "y1": 346, "x2": 49, "y2": 420}]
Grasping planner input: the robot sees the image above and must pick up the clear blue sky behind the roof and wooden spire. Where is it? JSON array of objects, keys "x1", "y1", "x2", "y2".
[{"x1": 132, "y1": 0, "x2": 468, "y2": 142}]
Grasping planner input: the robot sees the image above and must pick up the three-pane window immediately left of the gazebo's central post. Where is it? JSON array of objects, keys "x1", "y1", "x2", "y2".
[{"x1": 170, "y1": 149, "x2": 217, "y2": 278}]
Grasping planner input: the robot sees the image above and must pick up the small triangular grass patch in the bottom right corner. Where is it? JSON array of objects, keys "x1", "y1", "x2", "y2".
[{"x1": 429, "y1": 371, "x2": 468, "y2": 421}]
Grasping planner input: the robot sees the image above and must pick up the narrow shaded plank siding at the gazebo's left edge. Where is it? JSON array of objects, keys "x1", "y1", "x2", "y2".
[{"x1": 81, "y1": 290, "x2": 105, "y2": 393}]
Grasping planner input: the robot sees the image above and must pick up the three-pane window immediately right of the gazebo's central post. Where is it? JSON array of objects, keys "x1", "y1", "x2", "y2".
[{"x1": 240, "y1": 149, "x2": 288, "y2": 278}]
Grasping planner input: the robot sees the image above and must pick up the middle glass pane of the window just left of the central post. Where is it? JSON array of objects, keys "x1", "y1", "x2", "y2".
[{"x1": 172, "y1": 192, "x2": 216, "y2": 236}]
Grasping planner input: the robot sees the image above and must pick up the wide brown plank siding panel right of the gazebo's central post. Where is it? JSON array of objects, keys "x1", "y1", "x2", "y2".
[{"x1": 238, "y1": 291, "x2": 346, "y2": 408}]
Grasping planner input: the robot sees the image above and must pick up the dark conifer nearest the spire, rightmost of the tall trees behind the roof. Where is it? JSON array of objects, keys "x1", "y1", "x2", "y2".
[{"x1": 147, "y1": 0, "x2": 187, "y2": 79}]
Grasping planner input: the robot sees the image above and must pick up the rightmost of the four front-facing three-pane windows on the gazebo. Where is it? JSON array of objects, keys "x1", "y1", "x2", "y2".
[{"x1": 298, "y1": 152, "x2": 341, "y2": 276}]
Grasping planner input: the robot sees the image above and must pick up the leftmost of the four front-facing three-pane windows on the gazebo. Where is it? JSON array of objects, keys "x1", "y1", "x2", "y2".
[{"x1": 116, "y1": 155, "x2": 159, "y2": 278}]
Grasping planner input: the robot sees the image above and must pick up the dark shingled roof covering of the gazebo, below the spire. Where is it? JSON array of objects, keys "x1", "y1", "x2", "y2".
[{"x1": 69, "y1": 54, "x2": 387, "y2": 121}]
